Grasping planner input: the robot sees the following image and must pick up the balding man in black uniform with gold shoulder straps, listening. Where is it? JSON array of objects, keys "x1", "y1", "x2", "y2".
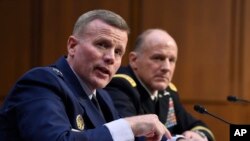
[{"x1": 106, "y1": 29, "x2": 214, "y2": 141}]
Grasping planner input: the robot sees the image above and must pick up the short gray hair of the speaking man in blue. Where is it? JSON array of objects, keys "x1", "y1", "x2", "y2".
[{"x1": 73, "y1": 9, "x2": 130, "y2": 35}]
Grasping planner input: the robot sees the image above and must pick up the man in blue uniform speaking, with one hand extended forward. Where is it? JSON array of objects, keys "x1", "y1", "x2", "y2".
[{"x1": 0, "y1": 10, "x2": 175, "y2": 141}]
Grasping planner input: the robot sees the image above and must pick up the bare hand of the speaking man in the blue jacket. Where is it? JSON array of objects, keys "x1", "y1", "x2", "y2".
[{"x1": 124, "y1": 114, "x2": 172, "y2": 141}]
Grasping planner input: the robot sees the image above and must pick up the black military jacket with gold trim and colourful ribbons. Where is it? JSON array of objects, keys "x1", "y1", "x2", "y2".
[{"x1": 105, "y1": 66, "x2": 213, "y2": 140}]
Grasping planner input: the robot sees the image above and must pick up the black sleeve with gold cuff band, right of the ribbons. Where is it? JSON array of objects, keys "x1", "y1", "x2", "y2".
[{"x1": 169, "y1": 86, "x2": 215, "y2": 141}]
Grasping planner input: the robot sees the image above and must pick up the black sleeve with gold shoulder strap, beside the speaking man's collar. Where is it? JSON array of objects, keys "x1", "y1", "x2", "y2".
[{"x1": 105, "y1": 77, "x2": 140, "y2": 117}]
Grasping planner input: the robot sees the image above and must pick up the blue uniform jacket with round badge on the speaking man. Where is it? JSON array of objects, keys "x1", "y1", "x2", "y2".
[{"x1": 0, "y1": 57, "x2": 119, "y2": 141}]
